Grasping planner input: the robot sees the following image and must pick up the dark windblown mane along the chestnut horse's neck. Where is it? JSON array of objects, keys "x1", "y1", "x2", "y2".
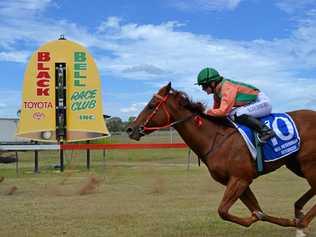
[{"x1": 172, "y1": 89, "x2": 233, "y2": 127}]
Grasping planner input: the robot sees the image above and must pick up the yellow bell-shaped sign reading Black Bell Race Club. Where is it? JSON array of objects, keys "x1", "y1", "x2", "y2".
[{"x1": 17, "y1": 39, "x2": 109, "y2": 142}]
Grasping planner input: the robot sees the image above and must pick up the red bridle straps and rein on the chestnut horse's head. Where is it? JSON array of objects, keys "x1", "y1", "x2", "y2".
[{"x1": 140, "y1": 93, "x2": 196, "y2": 134}]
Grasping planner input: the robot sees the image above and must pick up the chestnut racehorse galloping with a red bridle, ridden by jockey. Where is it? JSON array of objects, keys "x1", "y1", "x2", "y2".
[{"x1": 127, "y1": 83, "x2": 316, "y2": 236}]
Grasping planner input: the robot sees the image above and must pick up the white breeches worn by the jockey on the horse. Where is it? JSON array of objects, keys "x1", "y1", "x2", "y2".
[{"x1": 229, "y1": 92, "x2": 272, "y2": 118}]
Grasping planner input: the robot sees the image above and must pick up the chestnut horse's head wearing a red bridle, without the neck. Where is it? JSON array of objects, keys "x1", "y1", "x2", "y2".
[{"x1": 126, "y1": 82, "x2": 173, "y2": 141}]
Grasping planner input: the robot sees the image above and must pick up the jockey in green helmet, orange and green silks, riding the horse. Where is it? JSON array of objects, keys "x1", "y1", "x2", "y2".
[{"x1": 196, "y1": 68, "x2": 275, "y2": 143}]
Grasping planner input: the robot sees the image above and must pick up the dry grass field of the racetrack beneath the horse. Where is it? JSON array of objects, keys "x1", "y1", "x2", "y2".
[{"x1": 0, "y1": 132, "x2": 316, "y2": 237}]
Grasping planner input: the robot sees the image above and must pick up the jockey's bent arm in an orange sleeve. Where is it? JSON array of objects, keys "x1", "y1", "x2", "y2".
[{"x1": 207, "y1": 84, "x2": 237, "y2": 117}]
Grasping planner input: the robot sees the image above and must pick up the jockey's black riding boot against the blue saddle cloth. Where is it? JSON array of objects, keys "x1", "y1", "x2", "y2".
[{"x1": 234, "y1": 114, "x2": 275, "y2": 143}]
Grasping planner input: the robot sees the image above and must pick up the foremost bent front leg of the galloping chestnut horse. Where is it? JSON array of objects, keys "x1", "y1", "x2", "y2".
[{"x1": 218, "y1": 177, "x2": 258, "y2": 227}]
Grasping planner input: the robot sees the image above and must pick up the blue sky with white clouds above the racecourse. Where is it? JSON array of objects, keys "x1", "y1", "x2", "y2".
[{"x1": 0, "y1": 0, "x2": 316, "y2": 120}]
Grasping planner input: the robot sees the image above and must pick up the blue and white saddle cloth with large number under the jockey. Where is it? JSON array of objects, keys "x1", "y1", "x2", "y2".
[{"x1": 233, "y1": 113, "x2": 301, "y2": 162}]
